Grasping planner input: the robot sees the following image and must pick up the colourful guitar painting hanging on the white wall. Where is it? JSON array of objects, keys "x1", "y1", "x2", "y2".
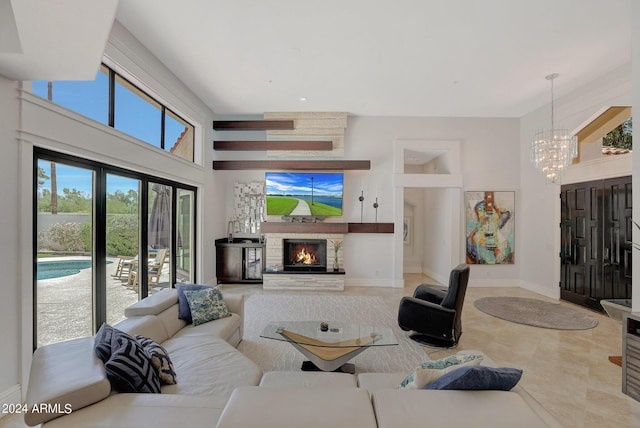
[{"x1": 465, "y1": 191, "x2": 515, "y2": 265}]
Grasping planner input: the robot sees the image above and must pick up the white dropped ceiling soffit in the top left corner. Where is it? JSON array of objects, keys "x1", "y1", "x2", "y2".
[{"x1": 0, "y1": 0, "x2": 118, "y2": 80}]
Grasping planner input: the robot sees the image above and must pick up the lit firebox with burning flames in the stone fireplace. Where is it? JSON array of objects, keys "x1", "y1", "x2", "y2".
[{"x1": 283, "y1": 239, "x2": 327, "y2": 271}]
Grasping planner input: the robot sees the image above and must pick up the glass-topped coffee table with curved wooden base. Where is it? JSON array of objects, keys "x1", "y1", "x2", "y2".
[{"x1": 260, "y1": 321, "x2": 398, "y2": 373}]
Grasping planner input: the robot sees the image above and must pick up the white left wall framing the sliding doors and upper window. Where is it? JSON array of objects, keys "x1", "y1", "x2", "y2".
[{"x1": 0, "y1": 24, "x2": 218, "y2": 403}]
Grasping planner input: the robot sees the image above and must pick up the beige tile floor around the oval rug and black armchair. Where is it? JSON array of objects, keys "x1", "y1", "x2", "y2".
[{"x1": 0, "y1": 274, "x2": 640, "y2": 428}]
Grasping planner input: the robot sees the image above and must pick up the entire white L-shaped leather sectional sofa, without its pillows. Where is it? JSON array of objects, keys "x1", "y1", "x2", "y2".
[{"x1": 25, "y1": 289, "x2": 561, "y2": 428}]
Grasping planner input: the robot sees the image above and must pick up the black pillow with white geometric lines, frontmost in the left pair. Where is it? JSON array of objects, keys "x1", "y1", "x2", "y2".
[{"x1": 104, "y1": 329, "x2": 160, "y2": 394}]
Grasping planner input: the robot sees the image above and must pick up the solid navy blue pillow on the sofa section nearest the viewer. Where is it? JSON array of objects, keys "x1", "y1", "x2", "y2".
[{"x1": 424, "y1": 366, "x2": 522, "y2": 391}]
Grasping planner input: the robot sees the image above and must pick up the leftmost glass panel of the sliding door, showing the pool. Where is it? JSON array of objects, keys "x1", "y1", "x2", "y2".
[{"x1": 34, "y1": 159, "x2": 95, "y2": 346}]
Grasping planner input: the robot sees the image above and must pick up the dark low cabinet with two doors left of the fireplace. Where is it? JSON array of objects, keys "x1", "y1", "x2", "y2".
[{"x1": 216, "y1": 238, "x2": 265, "y2": 283}]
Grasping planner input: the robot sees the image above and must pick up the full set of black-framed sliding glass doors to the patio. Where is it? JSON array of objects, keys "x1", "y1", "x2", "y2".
[{"x1": 34, "y1": 148, "x2": 196, "y2": 347}]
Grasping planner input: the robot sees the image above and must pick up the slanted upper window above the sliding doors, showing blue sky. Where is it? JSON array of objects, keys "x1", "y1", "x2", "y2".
[{"x1": 32, "y1": 64, "x2": 194, "y2": 162}]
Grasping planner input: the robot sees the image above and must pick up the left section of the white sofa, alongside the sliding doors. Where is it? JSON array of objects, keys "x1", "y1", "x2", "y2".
[{"x1": 25, "y1": 289, "x2": 262, "y2": 428}]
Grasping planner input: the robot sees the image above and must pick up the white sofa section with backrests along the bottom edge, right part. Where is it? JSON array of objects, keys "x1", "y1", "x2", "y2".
[{"x1": 217, "y1": 357, "x2": 562, "y2": 428}]
